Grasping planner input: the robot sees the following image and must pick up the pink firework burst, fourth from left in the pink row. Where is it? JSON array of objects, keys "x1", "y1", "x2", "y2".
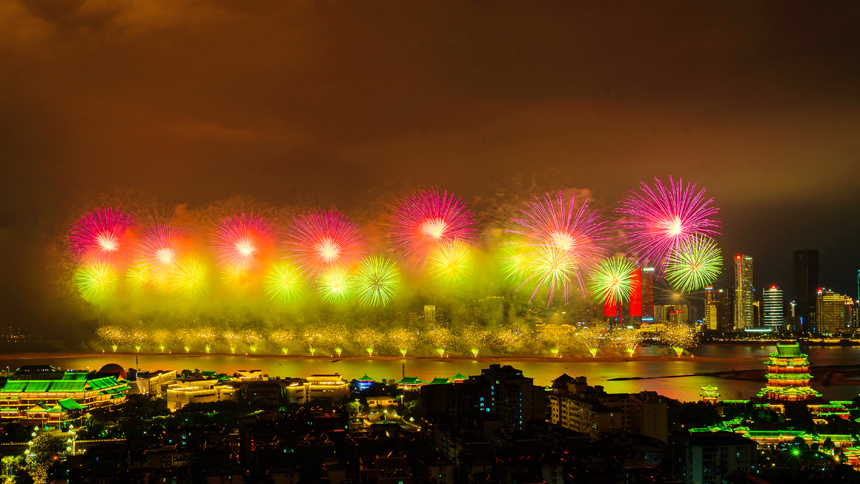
[{"x1": 286, "y1": 210, "x2": 364, "y2": 280}]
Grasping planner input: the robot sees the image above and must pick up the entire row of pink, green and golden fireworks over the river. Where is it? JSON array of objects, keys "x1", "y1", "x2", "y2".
[{"x1": 72, "y1": 179, "x2": 721, "y2": 358}]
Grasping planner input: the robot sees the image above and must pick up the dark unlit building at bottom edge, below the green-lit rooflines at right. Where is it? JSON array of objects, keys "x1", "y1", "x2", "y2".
[{"x1": 669, "y1": 432, "x2": 758, "y2": 484}]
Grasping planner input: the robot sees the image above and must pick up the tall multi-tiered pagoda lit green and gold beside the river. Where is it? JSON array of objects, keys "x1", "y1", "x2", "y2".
[{"x1": 757, "y1": 343, "x2": 821, "y2": 402}]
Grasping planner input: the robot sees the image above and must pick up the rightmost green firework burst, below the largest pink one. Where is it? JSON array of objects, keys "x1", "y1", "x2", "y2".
[{"x1": 666, "y1": 236, "x2": 723, "y2": 292}]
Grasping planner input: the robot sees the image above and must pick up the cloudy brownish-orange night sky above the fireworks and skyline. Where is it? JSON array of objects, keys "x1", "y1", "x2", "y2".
[{"x1": 0, "y1": 0, "x2": 860, "y2": 328}]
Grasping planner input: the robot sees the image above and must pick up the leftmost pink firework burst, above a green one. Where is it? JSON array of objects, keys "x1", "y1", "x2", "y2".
[{"x1": 67, "y1": 207, "x2": 135, "y2": 266}]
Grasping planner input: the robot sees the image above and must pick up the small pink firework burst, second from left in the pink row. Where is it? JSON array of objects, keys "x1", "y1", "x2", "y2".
[{"x1": 135, "y1": 225, "x2": 187, "y2": 285}]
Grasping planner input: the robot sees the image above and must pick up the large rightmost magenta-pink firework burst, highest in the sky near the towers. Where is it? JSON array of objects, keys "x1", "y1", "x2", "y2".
[{"x1": 616, "y1": 177, "x2": 720, "y2": 276}]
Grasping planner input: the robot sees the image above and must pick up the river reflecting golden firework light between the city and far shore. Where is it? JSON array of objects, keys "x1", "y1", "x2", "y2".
[{"x1": 0, "y1": 345, "x2": 860, "y2": 401}]
